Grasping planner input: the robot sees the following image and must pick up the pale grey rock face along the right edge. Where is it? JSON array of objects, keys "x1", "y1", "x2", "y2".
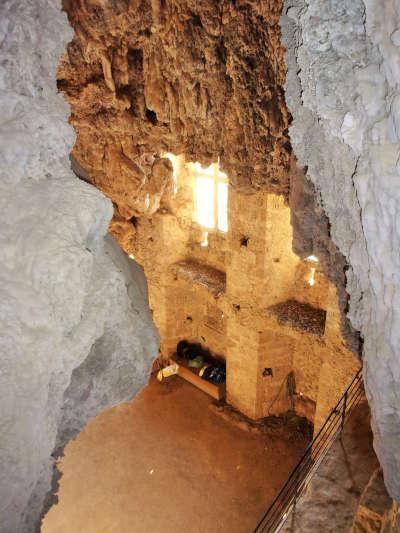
[{"x1": 281, "y1": 0, "x2": 400, "y2": 499}]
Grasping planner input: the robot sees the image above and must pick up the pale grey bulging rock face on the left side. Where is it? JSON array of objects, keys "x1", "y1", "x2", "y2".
[{"x1": 0, "y1": 0, "x2": 158, "y2": 533}]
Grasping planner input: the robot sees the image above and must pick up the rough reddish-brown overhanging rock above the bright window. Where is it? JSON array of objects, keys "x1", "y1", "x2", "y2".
[{"x1": 58, "y1": 0, "x2": 290, "y2": 219}]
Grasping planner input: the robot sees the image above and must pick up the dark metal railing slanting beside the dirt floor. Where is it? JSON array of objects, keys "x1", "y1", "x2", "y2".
[{"x1": 254, "y1": 369, "x2": 364, "y2": 533}]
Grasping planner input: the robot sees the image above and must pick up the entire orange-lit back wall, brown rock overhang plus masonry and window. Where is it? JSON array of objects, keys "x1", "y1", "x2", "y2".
[{"x1": 58, "y1": 0, "x2": 360, "y2": 429}]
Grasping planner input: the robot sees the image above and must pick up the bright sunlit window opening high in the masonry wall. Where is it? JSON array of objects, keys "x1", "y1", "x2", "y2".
[{"x1": 188, "y1": 159, "x2": 228, "y2": 233}]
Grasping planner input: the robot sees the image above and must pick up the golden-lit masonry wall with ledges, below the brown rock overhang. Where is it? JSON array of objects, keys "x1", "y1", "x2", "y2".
[{"x1": 130, "y1": 156, "x2": 360, "y2": 424}]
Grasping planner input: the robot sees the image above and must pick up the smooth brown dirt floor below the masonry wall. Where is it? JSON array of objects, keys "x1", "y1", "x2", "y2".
[{"x1": 42, "y1": 377, "x2": 306, "y2": 533}]
